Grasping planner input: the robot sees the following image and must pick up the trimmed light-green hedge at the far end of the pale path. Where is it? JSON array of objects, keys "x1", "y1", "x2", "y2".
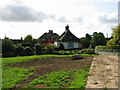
[{"x1": 95, "y1": 45, "x2": 120, "y2": 53}]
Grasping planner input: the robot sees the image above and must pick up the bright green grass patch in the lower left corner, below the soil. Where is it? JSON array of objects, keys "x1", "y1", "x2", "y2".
[{"x1": 2, "y1": 67, "x2": 33, "y2": 88}]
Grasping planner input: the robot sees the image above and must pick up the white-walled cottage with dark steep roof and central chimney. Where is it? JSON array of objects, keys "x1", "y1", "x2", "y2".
[{"x1": 54, "y1": 25, "x2": 80, "y2": 49}]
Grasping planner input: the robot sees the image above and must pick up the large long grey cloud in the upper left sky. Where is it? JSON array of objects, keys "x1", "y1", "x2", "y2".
[{"x1": 0, "y1": 6, "x2": 48, "y2": 22}]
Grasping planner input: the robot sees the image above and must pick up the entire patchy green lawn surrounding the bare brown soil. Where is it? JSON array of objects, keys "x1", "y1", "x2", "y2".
[{"x1": 2, "y1": 54, "x2": 94, "y2": 88}]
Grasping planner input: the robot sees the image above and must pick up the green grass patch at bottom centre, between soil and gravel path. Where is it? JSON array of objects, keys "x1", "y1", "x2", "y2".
[{"x1": 24, "y1": 67, "x2": 89, "y2": 88}]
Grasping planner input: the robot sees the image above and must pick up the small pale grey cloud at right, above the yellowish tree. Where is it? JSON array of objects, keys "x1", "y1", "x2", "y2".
[{"x1": 98, "y1": 15, "x2": 118, "y2": 23}]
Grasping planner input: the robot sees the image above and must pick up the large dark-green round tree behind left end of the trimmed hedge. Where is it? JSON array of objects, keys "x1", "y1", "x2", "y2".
[{"x1": 91, "y1": 32, "x2": 106, "y2": 48}]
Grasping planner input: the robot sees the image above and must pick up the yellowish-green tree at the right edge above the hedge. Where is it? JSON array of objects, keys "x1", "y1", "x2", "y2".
[{"x1": 107, "y1": 25, "x2": 120, "y2": 45}]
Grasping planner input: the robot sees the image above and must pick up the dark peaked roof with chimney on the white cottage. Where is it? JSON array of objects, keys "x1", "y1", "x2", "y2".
[{"x1": 57, "y1": 25, "x2": 80, "y2": 42}]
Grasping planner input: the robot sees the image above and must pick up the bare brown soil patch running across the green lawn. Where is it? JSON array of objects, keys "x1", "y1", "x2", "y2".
[{"x1": 10, "y1": 56, "x2": 93, "y2": 88}]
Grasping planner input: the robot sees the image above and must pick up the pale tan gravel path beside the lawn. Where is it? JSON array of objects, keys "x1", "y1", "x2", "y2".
[{"x1": 86, "y1": 54, "x2": 120, "y2": 88}]
